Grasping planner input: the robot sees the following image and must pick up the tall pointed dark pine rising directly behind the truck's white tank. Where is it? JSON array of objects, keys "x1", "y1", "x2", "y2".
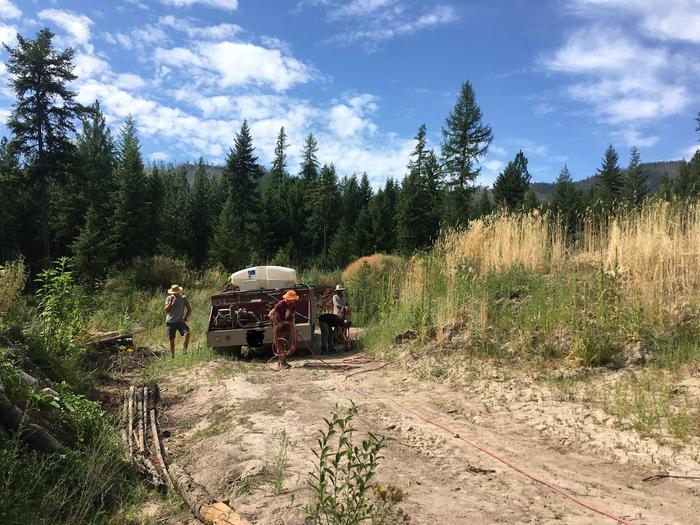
[{"x1": 212, "y1": 120, "x2": 263, "y2": 268}]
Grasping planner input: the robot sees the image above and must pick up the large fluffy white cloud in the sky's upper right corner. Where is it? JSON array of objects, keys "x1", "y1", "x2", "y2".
[{"x1": 536, "y1": 11, "x2": 700, "y2": 146}]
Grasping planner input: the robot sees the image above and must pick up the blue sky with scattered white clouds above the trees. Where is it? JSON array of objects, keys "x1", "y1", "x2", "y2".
[{"x1": 0, "y1": 0, "x2": 700, "y2": 186}]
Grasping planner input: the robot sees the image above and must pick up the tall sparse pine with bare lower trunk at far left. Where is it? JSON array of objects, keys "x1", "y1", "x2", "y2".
[{"x1": 3, "y1": 28, "x2": 82, "y2": 262}]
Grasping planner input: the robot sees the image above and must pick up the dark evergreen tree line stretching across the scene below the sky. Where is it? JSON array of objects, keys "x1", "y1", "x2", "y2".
[{"x1": 0, "y1": 29, "x2": 700, "y2": 279}]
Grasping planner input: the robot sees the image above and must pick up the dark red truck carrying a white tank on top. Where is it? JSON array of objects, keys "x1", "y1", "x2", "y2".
[{"x1": 207, "y1": 266, "x2": 316, "y2": 355}]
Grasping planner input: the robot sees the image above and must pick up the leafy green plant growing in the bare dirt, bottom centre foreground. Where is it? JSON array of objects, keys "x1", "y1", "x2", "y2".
[{"x1": 306, "y1": 403, "x2": 386, "y2": 525}]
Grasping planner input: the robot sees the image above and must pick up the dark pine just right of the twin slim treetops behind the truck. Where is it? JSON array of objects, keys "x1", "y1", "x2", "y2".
[{"x1": 307, "y1": 164, "x2": 341, "y2": 265}]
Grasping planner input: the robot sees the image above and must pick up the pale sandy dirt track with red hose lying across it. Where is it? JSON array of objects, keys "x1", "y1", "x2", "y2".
[{"x1": 154, "y1": 350, "x2": 700, "y2": 524}]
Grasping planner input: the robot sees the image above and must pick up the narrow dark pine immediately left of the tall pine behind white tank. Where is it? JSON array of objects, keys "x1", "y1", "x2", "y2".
[{"x1": 188, "y1": 157, "x2": 214, "y2": 268}]
